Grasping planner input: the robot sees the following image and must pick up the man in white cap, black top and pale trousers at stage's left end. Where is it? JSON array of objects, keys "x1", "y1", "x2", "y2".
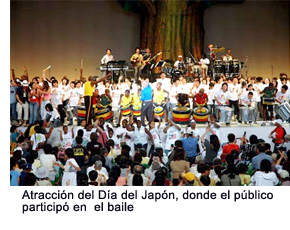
[{"x1": 16, "y1": 80, "x2": 29, "y2": 126}]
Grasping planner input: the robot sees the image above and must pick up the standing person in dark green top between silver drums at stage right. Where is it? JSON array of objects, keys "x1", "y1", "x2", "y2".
[{"x1": 261, "y1": 82, "x2": 276, "y2": 126}]
